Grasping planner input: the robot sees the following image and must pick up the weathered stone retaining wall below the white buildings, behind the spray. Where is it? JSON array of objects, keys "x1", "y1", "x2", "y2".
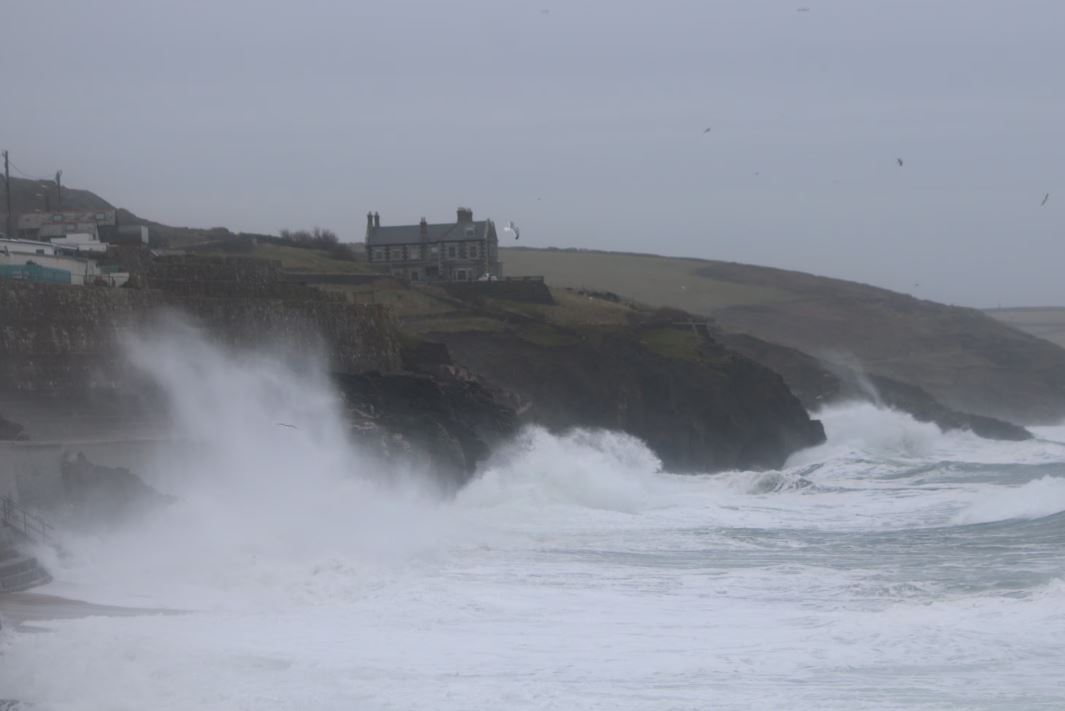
[{"x1": 0, "y1": 279, "x2": 400, "y2": 393}]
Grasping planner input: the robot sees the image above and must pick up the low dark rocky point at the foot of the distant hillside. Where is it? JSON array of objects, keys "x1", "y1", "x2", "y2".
[{"x1": 714, "y1": 331, "x2": 1032, "y2": 441}]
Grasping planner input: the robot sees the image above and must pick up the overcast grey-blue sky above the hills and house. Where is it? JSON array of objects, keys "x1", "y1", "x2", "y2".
[{"x1": 0, "y1": 0, "x2": 1065, "y2": 307}]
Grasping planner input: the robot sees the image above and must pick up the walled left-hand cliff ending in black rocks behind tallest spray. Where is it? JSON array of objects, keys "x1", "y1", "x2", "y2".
[{"x1": 0, "y1": 268, "x2": 517, "y2": 483}]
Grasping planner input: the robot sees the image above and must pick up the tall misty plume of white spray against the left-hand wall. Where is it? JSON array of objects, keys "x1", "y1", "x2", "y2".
[{"x1": 46, "y1": 318, "x2": 447, "y2": 606}]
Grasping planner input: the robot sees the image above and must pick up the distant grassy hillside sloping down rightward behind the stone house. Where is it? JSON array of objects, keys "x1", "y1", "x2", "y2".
[{"x1": 502, "y1": 249, "x2": 1065, "y2": 423}]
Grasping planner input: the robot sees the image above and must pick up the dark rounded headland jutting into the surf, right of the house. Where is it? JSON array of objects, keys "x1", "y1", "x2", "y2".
[{"x1": 432, "y1": 331, "x2": 824, "y2": 472}]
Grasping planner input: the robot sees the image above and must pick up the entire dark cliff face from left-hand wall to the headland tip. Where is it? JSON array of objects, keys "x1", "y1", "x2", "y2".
[{"x1": 0, "y1": 252, "x2": 824, "y2": 484}]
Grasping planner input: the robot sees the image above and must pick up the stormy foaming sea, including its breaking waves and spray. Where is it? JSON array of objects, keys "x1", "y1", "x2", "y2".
[{"x1": 0, "y1": 325, "x2": 1065, "y2": 711}]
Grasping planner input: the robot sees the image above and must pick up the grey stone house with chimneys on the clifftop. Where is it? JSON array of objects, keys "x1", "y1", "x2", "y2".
[{"x1": 366, "y1": 208, "x2": 503, "y2": 281}]
